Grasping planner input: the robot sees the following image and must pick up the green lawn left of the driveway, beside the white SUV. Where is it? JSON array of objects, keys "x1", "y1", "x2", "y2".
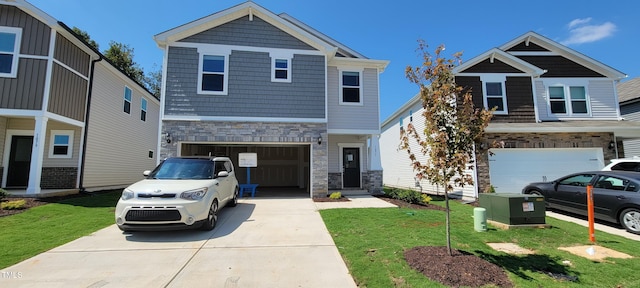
[{"x1": 0, "y1": 190, "x2": 122, "y2": 269}]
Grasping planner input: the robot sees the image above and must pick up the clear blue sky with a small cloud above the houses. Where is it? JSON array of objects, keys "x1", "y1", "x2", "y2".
[{"x1": 28, "y1": 0, "x2": 640, "y2": 120}]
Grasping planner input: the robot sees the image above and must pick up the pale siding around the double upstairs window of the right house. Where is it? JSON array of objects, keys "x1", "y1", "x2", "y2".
[{"x1": 534, "y1": 78, "x2": 619, "y2": 121}]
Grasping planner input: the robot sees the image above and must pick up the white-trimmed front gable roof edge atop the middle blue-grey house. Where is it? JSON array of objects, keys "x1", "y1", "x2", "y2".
[{"x1": 153, "y1": 1, "x2": 338, "y2": 56}]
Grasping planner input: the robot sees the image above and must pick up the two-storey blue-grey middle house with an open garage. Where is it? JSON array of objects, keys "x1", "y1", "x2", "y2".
[{"x1": 154, "y1": 1, "x2": 388, "y2": 197}]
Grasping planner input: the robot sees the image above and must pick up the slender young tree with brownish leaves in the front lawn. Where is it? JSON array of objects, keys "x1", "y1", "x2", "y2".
[{"x1": 400, "y1": 41, "x2": 492, "y2": 255}]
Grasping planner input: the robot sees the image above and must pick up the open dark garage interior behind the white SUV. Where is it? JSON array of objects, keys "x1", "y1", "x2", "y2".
[{"x1": 179, "y1": 142, "x2": 311, "y2": 197}]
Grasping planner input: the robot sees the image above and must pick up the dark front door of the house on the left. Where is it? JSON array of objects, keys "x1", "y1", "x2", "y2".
[{"x1": 7, "y1": 136, "x2": 33, "y2": 187}]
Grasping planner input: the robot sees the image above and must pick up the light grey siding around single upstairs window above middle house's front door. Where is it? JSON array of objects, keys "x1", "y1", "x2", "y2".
[{"x1": 327, "y1": 66, "x2": 380, "y2": 131}]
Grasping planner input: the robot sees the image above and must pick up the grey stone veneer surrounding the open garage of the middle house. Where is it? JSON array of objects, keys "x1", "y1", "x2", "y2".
[{"x1": 159, "y1": 121, "x2": 329, "y2": 197}]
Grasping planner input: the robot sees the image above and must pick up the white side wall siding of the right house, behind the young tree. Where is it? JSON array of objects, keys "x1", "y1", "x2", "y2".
[{"x1": 380, "y1": 102, "x2": 476, "y2": 199}]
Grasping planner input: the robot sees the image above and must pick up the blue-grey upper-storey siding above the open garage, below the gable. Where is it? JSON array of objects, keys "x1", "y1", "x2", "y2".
[{"x1": 165, "y1": 47, "x2": 325, "y2": 118}]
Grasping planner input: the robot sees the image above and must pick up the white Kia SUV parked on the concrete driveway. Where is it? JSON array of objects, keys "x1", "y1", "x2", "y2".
[{"x1": 115, "y1": 157, "x2": 238, "y2": 231}]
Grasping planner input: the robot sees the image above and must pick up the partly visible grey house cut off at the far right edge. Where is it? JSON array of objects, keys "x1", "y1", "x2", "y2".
[{"x1": 617, "y1": 78, "x2": 640, "y2": 157}]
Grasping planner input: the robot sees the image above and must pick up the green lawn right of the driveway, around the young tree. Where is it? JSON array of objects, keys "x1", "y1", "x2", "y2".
[{"x1": 320, "y1": 201, "x2": 640, "y2": 288}]
